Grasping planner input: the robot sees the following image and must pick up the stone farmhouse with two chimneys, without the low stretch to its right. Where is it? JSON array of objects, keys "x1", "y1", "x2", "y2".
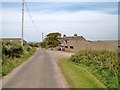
[{"x1": 56, "y1": 34, "x2": 88, "y2": 52}]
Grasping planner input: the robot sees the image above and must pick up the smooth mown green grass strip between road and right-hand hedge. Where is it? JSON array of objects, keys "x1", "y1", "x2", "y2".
[{"x1": 59, "y1": 60, "x2": 105, "y2": 88}]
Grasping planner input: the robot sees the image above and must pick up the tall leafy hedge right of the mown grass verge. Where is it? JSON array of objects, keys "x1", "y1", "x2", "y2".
[{"x1": 70, "y1": 50, "x2": 118, "y2": 88}]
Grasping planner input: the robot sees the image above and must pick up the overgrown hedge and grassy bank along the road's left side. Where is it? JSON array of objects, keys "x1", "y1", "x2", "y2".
[{"x1": 0, "y1": 43, "x2": 36, "y2": 76}]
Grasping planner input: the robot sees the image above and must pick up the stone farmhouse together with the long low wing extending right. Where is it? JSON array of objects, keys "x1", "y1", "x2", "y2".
[{"x1": 56, "y1": 34, "x2": 118, "y2": 52}]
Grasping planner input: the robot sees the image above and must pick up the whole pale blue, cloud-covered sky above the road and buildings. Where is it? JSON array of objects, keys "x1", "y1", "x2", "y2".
[{"x1": 0, "y1": 2, "x2": 118, "y2": 42}]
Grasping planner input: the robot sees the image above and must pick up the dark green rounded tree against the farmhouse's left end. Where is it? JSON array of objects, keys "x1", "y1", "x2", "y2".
[{"x1": 41, "y1": 32, "x2": 61, "y2": 47}]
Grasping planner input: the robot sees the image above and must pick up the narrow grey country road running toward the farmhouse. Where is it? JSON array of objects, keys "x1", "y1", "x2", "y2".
[{"x1": 3, "y1": 49, "x2": 69, "y2": 88}]
